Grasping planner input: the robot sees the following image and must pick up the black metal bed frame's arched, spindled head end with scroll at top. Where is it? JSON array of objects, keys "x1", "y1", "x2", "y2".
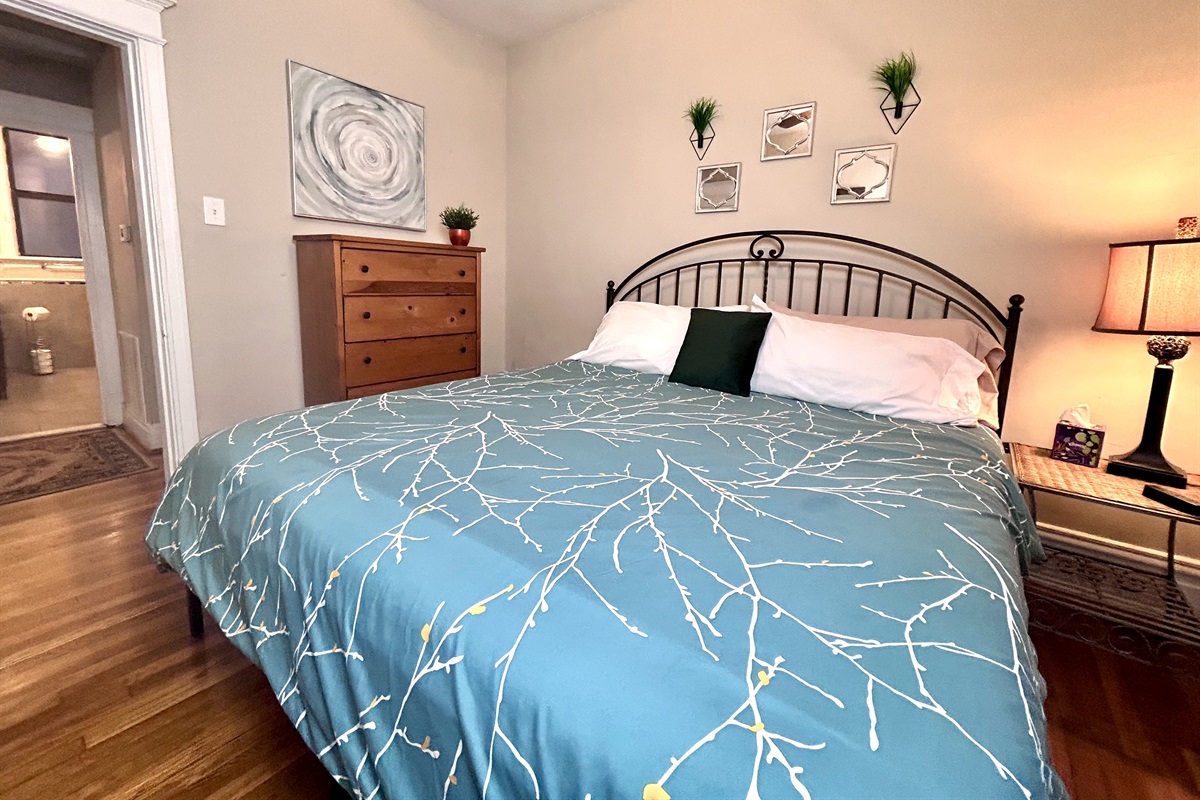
[{"x1": 605, "y1": 230, "x2": 1025, "y2": 426}]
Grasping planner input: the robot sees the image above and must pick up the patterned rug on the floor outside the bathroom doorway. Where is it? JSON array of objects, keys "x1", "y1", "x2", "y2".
[{"x1": 0, "y1": 428, "x2": 152, "y2": 505}]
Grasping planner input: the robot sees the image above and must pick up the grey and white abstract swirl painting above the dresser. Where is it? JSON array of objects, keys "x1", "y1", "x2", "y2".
[{"x1": 288, "y1": 61, "x2": 426, "y2": 230}]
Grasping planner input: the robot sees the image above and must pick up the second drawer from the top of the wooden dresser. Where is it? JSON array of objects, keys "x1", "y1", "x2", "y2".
[{"x1": 346, "y1": 295, "x2": 478, "y2": 342}]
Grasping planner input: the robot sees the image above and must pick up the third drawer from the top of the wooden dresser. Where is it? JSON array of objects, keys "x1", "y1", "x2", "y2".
[{"x1": 346, "y1": 333, "x2": 479, "y2": 386}]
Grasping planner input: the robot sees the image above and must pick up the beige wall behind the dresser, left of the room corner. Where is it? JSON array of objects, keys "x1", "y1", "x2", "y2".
[{"x1": 163, "y1": 0, "x2": 506, "y2": 432}]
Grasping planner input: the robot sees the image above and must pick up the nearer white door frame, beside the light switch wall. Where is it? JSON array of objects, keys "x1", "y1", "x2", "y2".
[{"x1": 0, "y1": 0, "x2": 199, "y2": 474}]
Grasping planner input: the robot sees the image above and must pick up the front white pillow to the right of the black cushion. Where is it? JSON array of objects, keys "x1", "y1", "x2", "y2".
[{"x1": 750, "y1": 297, "x2": 988, "y2": 426}]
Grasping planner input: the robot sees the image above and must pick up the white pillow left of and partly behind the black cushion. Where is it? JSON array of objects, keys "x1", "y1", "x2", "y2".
[{"x1": 569, "y1": 300, "x2": 750, "y2": 375}]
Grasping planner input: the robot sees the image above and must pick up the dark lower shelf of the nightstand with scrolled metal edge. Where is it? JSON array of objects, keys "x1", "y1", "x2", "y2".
[{"x1": 1025, "y1": 546, "x2": 1200, "y2": 678}]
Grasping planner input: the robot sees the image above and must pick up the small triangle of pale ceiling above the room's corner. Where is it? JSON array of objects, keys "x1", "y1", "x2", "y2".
[{"x1": 416, "y1": 0, "x2": 624, "y2": 46}]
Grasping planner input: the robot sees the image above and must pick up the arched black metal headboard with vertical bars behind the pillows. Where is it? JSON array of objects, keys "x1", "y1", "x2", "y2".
[{"x1": 606, "y1": 230, "x2": 1025, "y2": 425}]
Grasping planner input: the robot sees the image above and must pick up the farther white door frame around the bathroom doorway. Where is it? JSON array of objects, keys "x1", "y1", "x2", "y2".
[{"x1": 0, "y1": 91, "x2": 125, "y2": 425}]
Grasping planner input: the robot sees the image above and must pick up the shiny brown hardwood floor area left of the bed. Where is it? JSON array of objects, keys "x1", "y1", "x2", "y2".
[{"x1": 0, "y1": 462, "x2": 329, "y2": 800}]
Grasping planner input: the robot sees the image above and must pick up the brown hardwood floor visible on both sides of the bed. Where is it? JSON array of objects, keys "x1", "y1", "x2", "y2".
[{"x1": 0, "y1": 471, "x2": 1200, "y2": 800}]
